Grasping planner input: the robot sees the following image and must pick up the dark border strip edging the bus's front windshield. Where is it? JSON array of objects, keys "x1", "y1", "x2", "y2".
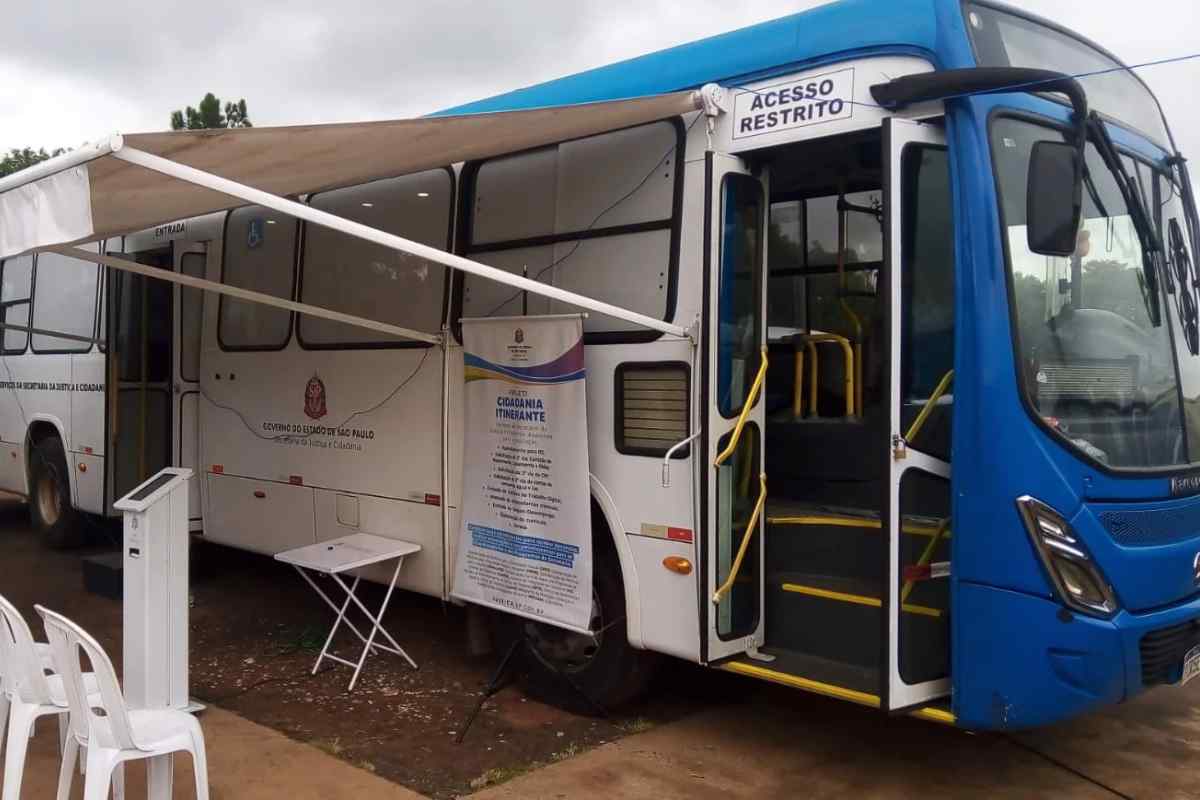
[{"x1": 986, "y1": 107, "x2": 1200, "y2": 479}]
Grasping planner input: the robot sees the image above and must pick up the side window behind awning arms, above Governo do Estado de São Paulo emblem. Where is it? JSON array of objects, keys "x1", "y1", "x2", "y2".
[{"x1": 300, "y1": 169, "x2": 454, "y2": 348}]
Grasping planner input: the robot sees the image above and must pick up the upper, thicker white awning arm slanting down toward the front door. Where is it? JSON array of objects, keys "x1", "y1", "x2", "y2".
[{"x1": 112, "y1": 148, "x2": 689, "y2": 338}]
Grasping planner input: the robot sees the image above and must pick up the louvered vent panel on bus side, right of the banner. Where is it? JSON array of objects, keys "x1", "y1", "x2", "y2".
[{"x1": 618, "y1": 365, "x2": 688, "y2": 456}]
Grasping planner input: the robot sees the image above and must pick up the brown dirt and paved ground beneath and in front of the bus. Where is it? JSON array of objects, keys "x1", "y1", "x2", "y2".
[{"x1": 7, "y1": 501, "x2": 1200, "y2": 800}]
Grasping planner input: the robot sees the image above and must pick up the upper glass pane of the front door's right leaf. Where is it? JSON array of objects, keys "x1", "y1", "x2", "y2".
[{"x1": 900, "y1": 145, "x2": 954, "y2": 461}]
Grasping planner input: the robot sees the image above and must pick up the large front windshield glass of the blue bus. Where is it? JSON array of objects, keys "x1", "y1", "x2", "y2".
[{"x1": 991, "y1": 118, "x2": 1200, "y2": 469}]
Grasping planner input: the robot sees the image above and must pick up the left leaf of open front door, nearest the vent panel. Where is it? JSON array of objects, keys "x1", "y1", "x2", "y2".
[{"x1": 700, "y1": 152, "x2": 767, "y2": 661}]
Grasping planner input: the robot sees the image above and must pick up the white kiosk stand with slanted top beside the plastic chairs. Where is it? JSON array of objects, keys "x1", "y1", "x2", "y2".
[{"x1": 113, "y1": 468, "x2": 199, "y2": 800}]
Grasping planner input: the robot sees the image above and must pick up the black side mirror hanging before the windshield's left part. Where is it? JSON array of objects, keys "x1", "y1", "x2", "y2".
[{"x1": 1025, "y1": 142, "x2": 1084, "y2": 257}]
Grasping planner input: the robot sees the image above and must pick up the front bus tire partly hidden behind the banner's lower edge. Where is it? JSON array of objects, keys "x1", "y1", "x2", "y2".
[{"x1": 492, "y1": 541, "x2": 658, "y2": 715}]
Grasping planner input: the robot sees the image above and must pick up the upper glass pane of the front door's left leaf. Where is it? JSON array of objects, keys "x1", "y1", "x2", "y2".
[{"x1": 716, "y1": 175, "x2": 763, "y2": 417}]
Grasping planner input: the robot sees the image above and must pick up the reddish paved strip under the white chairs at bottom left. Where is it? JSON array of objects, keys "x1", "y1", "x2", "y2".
[{"x1": 4, "y1": 709, "x2": 421, "y2": 800}]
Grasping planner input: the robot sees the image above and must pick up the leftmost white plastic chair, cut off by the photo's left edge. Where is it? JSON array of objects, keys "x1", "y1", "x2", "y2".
[{"x1": 0, "y1": 596, "x2": 96, "y2": 800}]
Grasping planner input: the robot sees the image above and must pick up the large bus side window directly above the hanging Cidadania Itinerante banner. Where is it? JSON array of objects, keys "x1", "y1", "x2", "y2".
[{"x1": 463, "y1": 122, "x2": 683, "y2": 333}]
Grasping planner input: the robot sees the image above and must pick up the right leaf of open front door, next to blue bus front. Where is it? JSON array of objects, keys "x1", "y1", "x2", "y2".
[{"x1": 881, "y1": 118, "x2": 958, "y2": 711}]
